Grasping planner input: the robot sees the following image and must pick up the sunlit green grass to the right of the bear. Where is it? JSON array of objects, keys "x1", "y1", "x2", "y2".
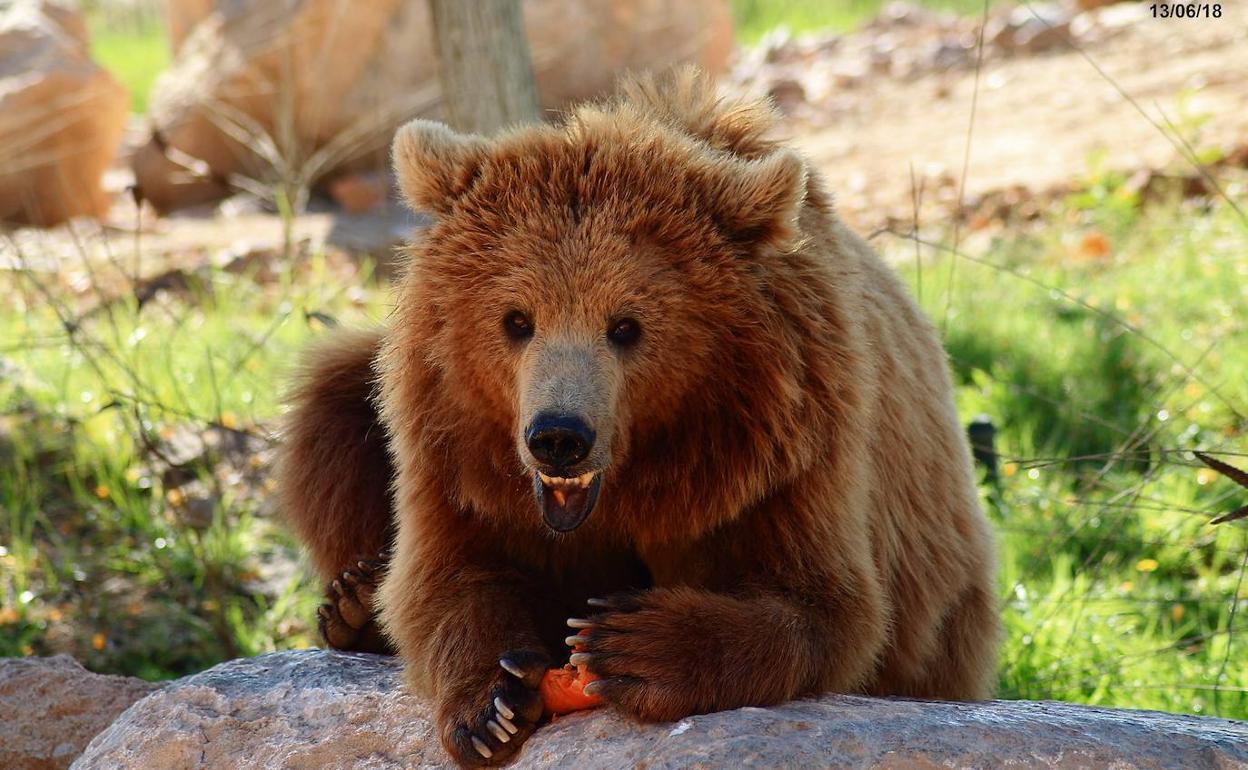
[{"x1": 889, "y1": 180, "x2": 1248, "y2": 719}]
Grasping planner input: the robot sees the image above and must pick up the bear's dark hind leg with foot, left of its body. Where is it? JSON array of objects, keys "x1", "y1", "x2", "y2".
[{"x1": 278, "y1": 331, "x2": 393, "y2": 651}]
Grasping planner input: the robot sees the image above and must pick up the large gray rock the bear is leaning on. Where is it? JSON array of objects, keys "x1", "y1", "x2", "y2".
[{"x1": 74, "y1": 650, "x2": 1248, "y2": 770}]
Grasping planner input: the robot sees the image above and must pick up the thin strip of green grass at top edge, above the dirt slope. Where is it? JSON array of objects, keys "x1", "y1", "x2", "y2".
[{"x1": 733, "y1": 0, "x2": 1002, "y2": 45}]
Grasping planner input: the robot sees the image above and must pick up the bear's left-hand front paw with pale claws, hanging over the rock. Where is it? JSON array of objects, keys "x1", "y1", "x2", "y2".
[{"x1": 439, "y1": 650, "x2": 550, "y2": 768}]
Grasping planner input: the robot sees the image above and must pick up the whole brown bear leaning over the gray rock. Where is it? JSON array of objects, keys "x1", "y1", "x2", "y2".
[{"x1": 282, "y1": 71, "x2": 998, "y2": 765}]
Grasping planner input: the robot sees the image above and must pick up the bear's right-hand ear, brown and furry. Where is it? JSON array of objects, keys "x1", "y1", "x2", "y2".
[{"x1": 709, "y1": 150, "x2": 806, "y2": 250}]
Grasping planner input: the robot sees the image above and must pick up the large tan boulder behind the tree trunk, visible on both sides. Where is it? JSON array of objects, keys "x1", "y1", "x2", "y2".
[{"x1": 134, "y1": 0, "x2": 733, "y2": 211}]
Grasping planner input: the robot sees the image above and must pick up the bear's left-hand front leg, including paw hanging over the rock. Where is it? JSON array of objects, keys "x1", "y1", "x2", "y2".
[{"x1": 378, "y1": 529, "x2": 554, "y2": 766}]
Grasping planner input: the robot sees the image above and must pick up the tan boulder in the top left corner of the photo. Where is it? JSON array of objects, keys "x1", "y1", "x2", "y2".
[{"x1": 0, "y1": 0, "x2": 130, "y2": 226}]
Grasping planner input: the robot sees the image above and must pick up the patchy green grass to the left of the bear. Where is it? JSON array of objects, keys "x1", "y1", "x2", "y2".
[{"x1": 0, "y1": 249, "x2": 384, "y2": 679}]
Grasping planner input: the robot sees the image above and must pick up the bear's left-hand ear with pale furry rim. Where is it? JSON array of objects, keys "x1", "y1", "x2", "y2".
[{"x1": 391, "y1": 120, "x2": 489, "y2": 213}]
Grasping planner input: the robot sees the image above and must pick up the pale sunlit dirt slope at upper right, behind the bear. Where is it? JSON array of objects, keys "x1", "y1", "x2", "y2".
[{"x1": 738, "y1": 2, "x2": 1248, "y2": 230}]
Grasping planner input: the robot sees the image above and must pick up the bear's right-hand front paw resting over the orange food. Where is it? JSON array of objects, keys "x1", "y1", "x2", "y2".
[{"x1": 568, "y1": 592, "x2": 714, "y2": 721}]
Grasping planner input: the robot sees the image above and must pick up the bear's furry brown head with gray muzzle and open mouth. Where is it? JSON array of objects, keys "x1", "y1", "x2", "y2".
[{"x1": 381, "y1": 73, "x2": 848, "y2": 541}]
